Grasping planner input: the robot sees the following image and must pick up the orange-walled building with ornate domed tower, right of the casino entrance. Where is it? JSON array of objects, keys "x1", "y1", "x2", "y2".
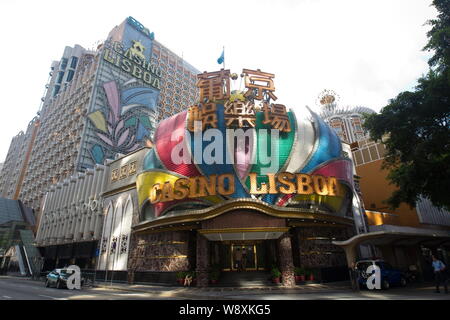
[{"x1": 319, "y1": 90, "x2": 450, "y2": 280}]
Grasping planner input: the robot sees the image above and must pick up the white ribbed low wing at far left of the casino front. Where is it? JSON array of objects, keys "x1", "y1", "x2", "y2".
[{"x1": 36, "y1": 164, "x2": 107, "y2": 270}]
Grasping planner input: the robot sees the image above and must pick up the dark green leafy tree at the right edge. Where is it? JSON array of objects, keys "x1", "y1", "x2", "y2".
[{"x1": 364, "y1": 0, "x2": 450, "y2": 210}]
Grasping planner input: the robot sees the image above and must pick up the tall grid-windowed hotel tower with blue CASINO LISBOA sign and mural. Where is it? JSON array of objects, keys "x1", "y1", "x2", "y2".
[{"x1": 0, "y1": 17, "x2": 198, "y2": 221}]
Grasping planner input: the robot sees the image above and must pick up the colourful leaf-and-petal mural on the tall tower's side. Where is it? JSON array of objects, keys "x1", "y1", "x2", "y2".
[{"x1": 87, "y1": 81, "x2": 159, "y2": 163}]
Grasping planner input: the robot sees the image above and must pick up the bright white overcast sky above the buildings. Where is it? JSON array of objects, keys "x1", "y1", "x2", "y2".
[{"x1": 0, "y1": 0, "x2": 436, "y2": 162}]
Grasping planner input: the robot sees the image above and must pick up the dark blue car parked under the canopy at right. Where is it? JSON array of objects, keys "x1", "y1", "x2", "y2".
[{"x1": 356, "y1": 260, "x2": 407, "y2": 290}]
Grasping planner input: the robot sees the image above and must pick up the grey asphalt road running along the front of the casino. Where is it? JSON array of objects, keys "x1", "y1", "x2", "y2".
[{"x1": 0, "y1": 276, "x2": 450, "y2": 301}]
